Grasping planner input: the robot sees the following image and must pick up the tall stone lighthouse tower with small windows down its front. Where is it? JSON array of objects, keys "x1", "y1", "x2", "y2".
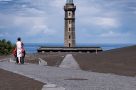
[{"x1": 64, "y1": 0, "x2": 76, "y2": 47}]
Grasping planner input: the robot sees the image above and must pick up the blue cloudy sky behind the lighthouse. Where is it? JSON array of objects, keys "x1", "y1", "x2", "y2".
[{"x1": 0, "y1": 0, "x2": 136, "y2": 44}]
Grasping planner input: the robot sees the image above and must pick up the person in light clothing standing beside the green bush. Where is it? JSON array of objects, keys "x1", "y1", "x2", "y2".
[{"x1": 16, "y1": 37, "x2": 23, "y2": 64}]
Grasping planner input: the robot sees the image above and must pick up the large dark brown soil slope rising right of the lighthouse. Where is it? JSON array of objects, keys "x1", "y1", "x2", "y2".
[{"x1": 73, "y1": 46, "x2": 136, "y2": 76}]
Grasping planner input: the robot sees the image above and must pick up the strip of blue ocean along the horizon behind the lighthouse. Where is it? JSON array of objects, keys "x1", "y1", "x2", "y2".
[{"x1": 24, "y1": 43, "x2": 134, "y2": 54}]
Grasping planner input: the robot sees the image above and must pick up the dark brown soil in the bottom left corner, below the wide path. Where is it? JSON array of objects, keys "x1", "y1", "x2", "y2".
[{"x1": 0, "y1": 69, "x2": 44, "y2": 90}]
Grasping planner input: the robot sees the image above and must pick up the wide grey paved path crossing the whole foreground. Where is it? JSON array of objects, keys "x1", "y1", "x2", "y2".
[{"x1": 0, "y1": 62, "x2": 136, "y2": 90}]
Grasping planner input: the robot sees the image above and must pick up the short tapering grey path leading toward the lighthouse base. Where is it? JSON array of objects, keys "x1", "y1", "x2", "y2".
[{"x1": 59, "y1": 54, "x2": 80, "y2": 69}]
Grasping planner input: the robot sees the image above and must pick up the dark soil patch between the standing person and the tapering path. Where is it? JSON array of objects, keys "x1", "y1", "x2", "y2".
[{"x1": 25, "y1": 52, "x2": 67, "y2": 66}]
